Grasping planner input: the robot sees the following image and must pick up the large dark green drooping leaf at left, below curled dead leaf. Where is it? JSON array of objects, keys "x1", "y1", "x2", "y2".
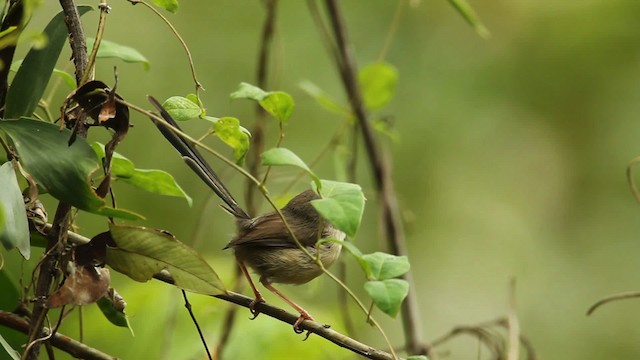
[{"x1": 0, "y1": 119, "x2": 142, "y2": 220}]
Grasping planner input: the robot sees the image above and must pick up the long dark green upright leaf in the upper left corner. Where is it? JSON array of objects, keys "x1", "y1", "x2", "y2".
[{"x1": 4, "y1": 5, "x2": 92, "y2": 119}]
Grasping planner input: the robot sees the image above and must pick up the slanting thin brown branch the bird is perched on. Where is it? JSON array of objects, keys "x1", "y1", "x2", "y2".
[{"x1": 31, "y1": 220, "x2": 393, "y2": 360}]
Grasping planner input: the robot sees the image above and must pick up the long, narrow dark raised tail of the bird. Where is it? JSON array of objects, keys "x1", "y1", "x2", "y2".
[{"x1": 148, "y1": 96, "x2": 250, "y2": 219}]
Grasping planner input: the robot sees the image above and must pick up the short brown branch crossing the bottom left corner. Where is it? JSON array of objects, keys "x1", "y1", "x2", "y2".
[{"x1": 0, "y1": 310, "x2": 115, "y2": 360}]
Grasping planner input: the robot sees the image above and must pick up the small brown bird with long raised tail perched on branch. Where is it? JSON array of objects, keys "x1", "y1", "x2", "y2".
[{"x1": 149, "y1": 97, "x2": 345, "y2": 332}]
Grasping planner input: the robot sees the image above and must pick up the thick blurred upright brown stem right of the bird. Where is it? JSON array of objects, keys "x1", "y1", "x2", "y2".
[{"x1": 325, "y1": 0, "x2": 428, "y2": 354}]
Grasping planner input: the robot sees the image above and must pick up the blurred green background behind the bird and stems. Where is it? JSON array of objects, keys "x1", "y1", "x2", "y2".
[{"x1": 0, "y1": 0, "x2": 640, "y2": 360}]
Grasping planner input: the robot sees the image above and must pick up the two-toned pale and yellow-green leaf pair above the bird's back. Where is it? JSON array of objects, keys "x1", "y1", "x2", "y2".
[{"x1": 231, "y1": 82, "x2": 295, "y2": 123}]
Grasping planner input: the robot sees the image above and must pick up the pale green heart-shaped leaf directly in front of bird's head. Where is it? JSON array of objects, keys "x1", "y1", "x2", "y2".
[{"x1": 311, "y1": 180, "x2": 365, "y2": 237}]
